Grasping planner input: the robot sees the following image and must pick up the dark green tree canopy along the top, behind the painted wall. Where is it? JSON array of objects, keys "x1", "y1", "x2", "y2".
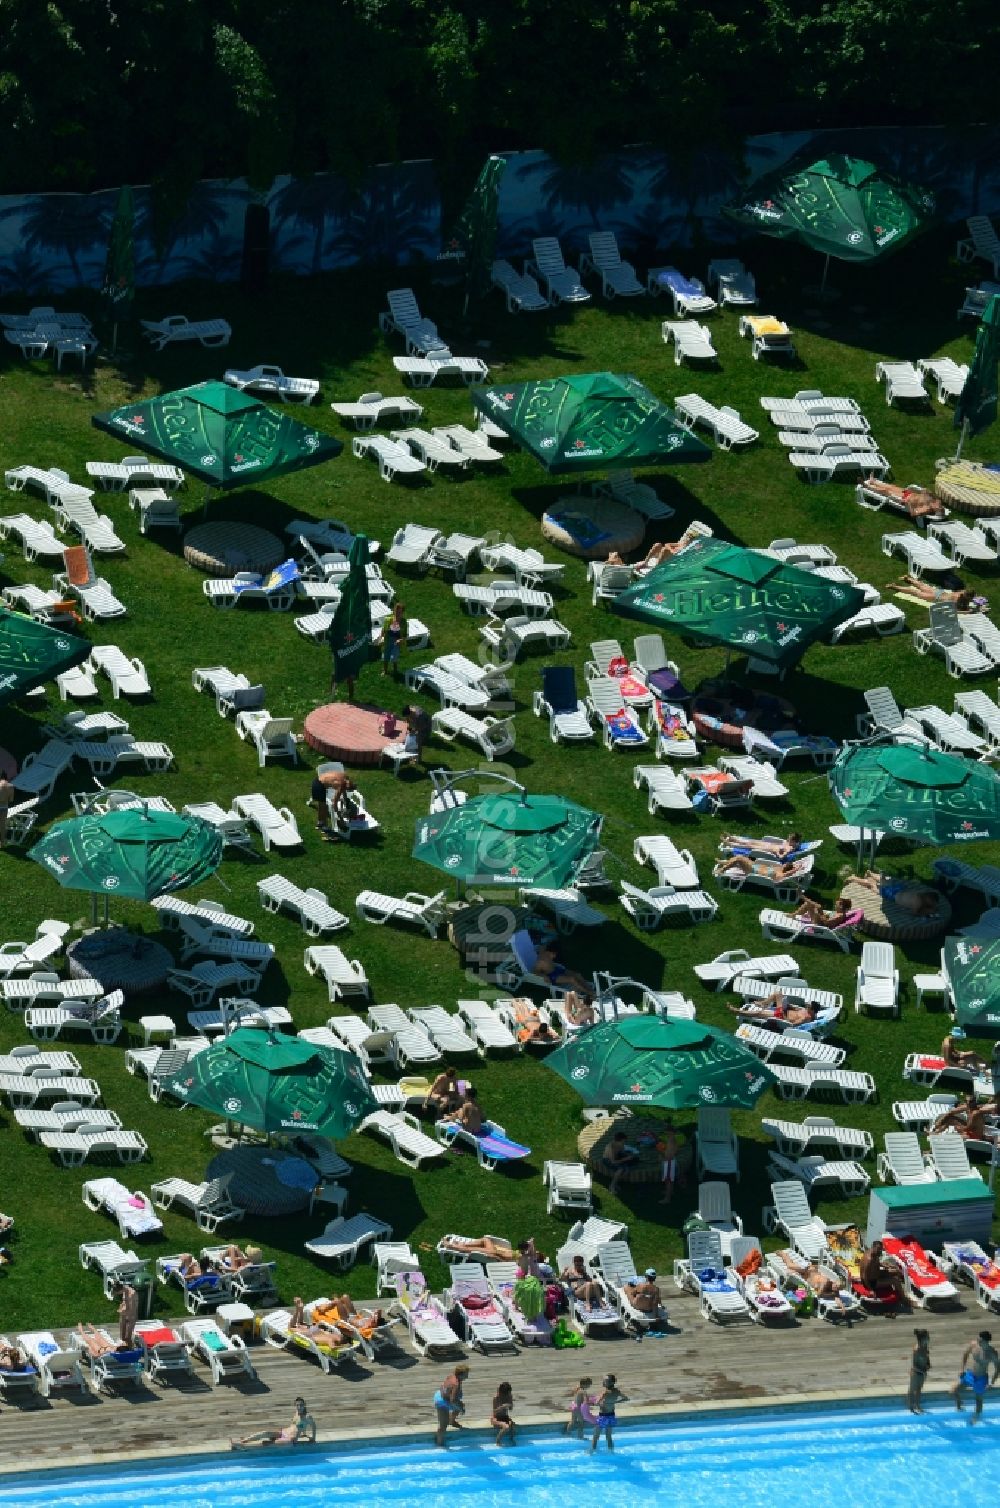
[{"x1": 0, "y1": 0, "x2": 1000, "y2": 197}]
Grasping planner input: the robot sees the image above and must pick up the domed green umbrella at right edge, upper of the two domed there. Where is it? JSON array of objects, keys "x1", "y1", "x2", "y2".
[{"x1": 830, "y1": 743, "x2": 1000, "y2": 843}]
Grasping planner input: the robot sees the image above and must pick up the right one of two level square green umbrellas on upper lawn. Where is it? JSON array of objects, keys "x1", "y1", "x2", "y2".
[{"x1": 472, "y1": 372, "x2": 712, "y2": 472}]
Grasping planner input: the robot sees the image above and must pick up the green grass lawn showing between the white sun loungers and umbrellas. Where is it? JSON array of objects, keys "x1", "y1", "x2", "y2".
[{"x1": 0, "y1": 229, "x2": 997, "y2": 1332}]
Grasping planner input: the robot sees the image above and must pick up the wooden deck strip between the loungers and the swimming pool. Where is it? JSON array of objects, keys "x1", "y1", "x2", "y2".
[{"x1": 0, "y1": 1285, "x2": 983, "y2": 1472}]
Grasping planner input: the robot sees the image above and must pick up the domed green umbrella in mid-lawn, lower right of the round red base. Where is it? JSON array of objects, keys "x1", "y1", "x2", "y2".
[{"x1": 413, "y1": 792, "x2": 602, "y2": 888}]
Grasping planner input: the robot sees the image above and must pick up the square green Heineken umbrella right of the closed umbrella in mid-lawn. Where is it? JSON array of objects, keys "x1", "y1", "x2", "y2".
[{"x1": 614, "y1": 538, "x2": 864, "y2": 668}]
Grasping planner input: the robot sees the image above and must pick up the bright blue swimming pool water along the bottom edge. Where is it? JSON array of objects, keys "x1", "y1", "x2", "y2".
[{"x1": 0, "y1": 1399, "x2": 1000, "y2": 1508}]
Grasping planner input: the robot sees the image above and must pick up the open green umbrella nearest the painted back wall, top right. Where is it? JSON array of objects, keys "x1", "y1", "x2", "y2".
[{"x1": 722, "y1": 152, "x2": 937, "y2": 262}]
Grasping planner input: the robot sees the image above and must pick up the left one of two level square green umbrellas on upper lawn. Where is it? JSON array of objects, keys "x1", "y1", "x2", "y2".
[{"x1": 90, "y1": 382, "x2": 344, "y2": 492}]
